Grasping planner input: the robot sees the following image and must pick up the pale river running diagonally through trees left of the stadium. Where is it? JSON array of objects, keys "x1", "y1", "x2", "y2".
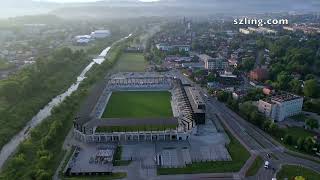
[{"x1": 0, "y1": 34, "x2": 132, "y2": 170}]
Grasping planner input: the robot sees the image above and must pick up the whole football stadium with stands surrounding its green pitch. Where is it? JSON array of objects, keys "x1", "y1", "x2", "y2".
[{"x1": 73, "y1": 72, "x2": 205, "y2": 143}]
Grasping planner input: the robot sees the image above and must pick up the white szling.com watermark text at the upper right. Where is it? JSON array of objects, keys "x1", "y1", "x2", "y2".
[{"x1": 233, "y1": 18, "x2": 289, "y2": 27}]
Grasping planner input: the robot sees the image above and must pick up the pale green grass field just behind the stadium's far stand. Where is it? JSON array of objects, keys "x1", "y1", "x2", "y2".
[{"x1": 114, "y1": 53, "x2": 147, "y2": 72}]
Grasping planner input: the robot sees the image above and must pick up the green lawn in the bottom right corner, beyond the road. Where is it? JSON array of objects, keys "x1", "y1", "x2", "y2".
[{"x1": 277, "y1": 165, "x2": 320, "y2": 180}]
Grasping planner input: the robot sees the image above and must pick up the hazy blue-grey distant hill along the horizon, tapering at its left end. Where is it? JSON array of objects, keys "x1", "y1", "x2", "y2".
[{"x1": 53, "y1": 0, "x2": 320, "y2": 18}]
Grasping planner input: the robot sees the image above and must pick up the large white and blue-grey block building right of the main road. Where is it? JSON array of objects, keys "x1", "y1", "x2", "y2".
[{"x1": 258, "y1": 92, "x2": 303, "y2": 121}]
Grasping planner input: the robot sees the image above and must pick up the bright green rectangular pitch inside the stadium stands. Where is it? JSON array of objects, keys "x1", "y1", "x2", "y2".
[{"x1": 102, "y1": 91, "x2": 173, "y2": 118}]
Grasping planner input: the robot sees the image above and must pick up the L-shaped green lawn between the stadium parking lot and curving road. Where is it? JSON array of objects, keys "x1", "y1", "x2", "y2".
[{"x1": 157, "y1": 124, "x2": 250, "y2": 175}]
